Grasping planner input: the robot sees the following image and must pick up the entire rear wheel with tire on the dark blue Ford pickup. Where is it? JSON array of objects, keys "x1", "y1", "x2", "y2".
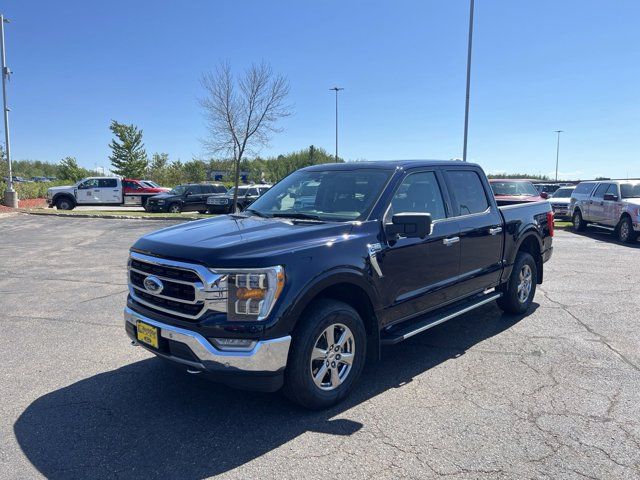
[{"x1": 497, "y1": 252, "x2": 538, "y2": 314}]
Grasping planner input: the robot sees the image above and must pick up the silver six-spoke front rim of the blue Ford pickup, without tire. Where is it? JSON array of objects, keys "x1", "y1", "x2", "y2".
[{"x1": 309, "y1": 323, "x2": 356, "y2": 391}]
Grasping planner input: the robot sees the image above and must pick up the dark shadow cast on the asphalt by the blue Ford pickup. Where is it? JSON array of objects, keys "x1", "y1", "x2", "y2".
[{"x1": 14, "y1": 303, "x2": 538, "y2": 479}]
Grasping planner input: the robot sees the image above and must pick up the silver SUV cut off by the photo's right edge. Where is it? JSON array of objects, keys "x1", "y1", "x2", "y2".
[{"x1": 569, "y1": 180, "x2": 640, "y2": 243}]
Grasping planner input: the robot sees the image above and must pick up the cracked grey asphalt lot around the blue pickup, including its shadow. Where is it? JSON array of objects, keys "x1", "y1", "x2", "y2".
[{"x1": 0, "y1": 215, "x2": 640, "y2": 480}]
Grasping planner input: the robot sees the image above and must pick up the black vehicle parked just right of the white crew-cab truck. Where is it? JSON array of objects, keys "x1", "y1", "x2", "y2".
[{"x1": 145, "y1": 183, "x2": 227, "y2": 213}]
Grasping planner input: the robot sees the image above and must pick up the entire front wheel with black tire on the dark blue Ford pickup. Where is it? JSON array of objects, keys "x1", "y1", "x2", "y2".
[{"x1": 284, "y1": 300, "x2": 367, "y2": 410}]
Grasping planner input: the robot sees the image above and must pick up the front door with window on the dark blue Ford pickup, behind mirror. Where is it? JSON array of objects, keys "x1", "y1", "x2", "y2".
[{"x1": 377, "y1": 171, "x2": 460, "y2": 323}]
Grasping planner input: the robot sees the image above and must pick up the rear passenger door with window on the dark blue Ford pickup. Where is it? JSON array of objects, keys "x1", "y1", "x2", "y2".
[{"x1": 445, "y1": 168, "x2": 504, "y2": 297}]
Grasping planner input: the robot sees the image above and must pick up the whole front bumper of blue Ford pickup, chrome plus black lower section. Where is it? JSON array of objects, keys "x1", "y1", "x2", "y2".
[{"x1": 124, "y1": 307, "x2": 291, "y2": 391}]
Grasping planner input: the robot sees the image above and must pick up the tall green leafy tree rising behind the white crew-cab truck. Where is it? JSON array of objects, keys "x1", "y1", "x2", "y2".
[{"x1": 109, "y1": 120, "x2": 149, "y2": 178}]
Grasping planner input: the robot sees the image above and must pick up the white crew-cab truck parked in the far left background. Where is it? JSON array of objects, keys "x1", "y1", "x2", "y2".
[{"x1": 47, "y1": 177, "x2": 166, "y2": 210}]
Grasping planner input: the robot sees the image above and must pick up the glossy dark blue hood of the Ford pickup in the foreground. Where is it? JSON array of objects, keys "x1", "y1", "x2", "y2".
[{"x1": 132, "y1": 215, "x2": 353, "y2": 268}]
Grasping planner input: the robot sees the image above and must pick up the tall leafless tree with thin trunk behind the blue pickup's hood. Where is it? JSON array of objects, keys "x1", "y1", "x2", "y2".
[{"x1": 200, "y1": 62, "x2": 291, "y2": 211}]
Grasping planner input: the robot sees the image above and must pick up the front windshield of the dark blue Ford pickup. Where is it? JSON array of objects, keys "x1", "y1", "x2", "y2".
[{"x1": 251, "y1": 169, "x2": 392, "y2": 222}]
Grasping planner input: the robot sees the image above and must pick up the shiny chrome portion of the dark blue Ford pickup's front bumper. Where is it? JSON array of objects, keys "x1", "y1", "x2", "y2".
[{"x1": 124, "y1": 307, "x2": 291, "y2": 373}]
